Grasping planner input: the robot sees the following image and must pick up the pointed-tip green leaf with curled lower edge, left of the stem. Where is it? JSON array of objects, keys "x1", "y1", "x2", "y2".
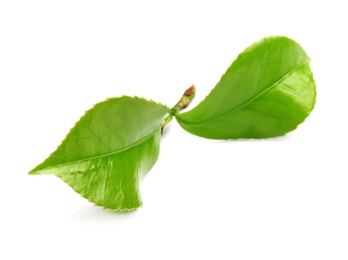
[{"x1": 30, "y1": 96, "x2": 170, "y2": 210}]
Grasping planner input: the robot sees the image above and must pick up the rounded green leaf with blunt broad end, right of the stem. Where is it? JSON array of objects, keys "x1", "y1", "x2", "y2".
[{"x1": 176, "y1": 36, "x2": 316, "y2": 139}]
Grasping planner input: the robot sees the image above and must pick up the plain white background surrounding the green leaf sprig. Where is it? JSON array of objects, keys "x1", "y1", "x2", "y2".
[{"x1": 0, "y1": 0, "x2": 348, "y2": 260}]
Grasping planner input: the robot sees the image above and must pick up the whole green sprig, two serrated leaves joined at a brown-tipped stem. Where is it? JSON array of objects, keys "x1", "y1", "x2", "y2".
[{"x1": 30, "y1": 36, "x2": 316, "y2": 210}]
